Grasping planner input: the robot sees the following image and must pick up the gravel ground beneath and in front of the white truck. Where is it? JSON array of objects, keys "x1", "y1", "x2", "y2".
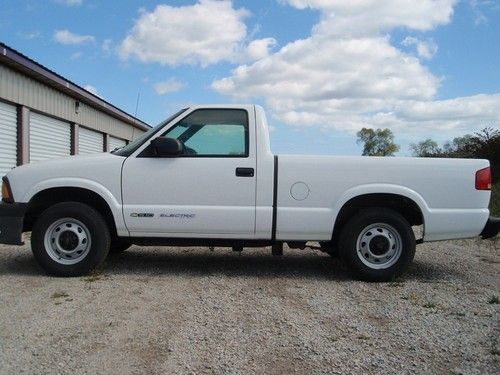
[{"x1": 0, "y1": 236, "x2": 500, "y2": 374}]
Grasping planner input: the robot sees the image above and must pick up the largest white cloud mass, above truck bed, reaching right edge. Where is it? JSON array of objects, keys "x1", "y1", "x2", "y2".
[{"x1": 212, "y1": 0, "x2": 500, "y2": 138}]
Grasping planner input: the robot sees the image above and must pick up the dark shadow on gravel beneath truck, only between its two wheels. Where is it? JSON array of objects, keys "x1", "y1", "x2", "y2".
[{"x1": 104, "y1": 249, "x2": 351, "y2": 280}]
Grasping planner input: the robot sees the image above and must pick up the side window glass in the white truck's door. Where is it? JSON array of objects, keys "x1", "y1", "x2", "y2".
[{"x1": 162, "y1": 109, "x2": 248, "y2": 157}]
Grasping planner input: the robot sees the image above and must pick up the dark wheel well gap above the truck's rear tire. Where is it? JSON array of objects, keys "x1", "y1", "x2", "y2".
[{"x1": 332, "y1": 194, "x2": 424, "y2": 242}]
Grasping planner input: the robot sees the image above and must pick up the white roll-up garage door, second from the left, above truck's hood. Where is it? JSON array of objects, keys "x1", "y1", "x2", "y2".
[{"x1": 30, "y1": 112, "x2": 71, "y2": 162}]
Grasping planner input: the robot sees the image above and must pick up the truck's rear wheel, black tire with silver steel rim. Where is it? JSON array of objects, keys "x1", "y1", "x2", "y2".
[{"x1": 339, "y1": 208, "x2": 416, "y2": 281}]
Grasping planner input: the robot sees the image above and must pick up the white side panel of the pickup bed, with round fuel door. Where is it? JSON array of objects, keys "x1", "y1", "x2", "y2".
[{"x1": 276, "y1": 155, "x2": 490, "y2": 241}]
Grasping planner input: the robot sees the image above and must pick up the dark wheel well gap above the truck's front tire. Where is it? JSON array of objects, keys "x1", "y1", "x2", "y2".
[{"x1": 23, "y1": 187, "x2": 117, "y2": 236}]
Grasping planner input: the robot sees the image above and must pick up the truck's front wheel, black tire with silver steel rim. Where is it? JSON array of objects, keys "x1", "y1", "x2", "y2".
[{"x1": 31, "y1": 202, "x2": 111, "y2": 276}]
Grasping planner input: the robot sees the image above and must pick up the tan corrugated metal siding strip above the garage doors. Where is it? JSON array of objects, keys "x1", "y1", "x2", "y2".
[{"x1": 0, "y1": 65, "x2": 143, "y2": 140}]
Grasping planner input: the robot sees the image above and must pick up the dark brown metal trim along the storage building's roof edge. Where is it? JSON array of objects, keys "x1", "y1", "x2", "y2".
[{"x1": 0, "y1": 42, "x2": 150, "y2": 130}]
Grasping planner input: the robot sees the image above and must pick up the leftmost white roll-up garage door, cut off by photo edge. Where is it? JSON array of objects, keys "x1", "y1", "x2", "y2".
[{"x1": 0, "y1": 102, "x2": 17, "y2": 177}]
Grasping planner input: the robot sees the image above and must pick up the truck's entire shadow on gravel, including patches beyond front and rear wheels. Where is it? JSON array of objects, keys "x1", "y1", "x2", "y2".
[{"x1": 0, "y1": 247, "x2": 461, "y2": 282}]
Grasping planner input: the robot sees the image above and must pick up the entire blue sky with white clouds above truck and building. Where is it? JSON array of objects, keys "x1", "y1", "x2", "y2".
[{"x1": 0, "y1": 0, "x2": 500, "y2": 156}]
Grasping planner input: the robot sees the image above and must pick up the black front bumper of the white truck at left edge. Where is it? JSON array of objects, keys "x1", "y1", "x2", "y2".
[{"x1": 0, "y1": 202, "x2": 28, "y2": 245}]
